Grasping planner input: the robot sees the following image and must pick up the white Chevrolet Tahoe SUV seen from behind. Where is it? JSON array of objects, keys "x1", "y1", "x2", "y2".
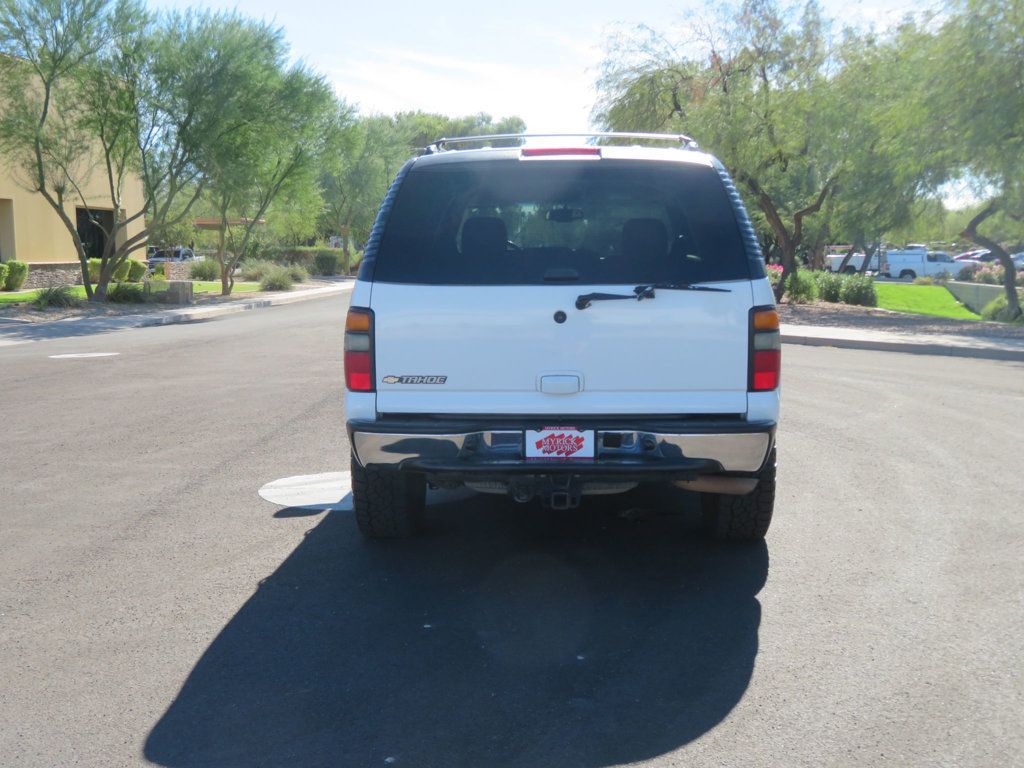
[{"x1": 345, "y1": 134, "x2": 780, "y2": 539}]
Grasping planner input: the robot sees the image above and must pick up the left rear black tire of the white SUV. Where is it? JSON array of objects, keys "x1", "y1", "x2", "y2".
[{"x1": 352, "y1": 459, "x2": 427, "y2": 539}]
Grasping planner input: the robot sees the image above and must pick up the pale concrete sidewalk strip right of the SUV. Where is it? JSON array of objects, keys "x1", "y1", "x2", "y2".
[{"x1": 782, "y1": 324, "x2": 1024, "y2": 360}]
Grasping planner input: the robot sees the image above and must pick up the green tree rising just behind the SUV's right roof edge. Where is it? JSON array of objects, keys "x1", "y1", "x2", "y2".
[{"x1": 596, "y1": 0, "x2": 850, "y2": 296}]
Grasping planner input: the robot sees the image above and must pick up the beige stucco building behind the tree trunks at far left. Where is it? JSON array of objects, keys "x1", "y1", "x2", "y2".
[{"x1": 0, "y1": 157, "x2": 144, "y2": 269}]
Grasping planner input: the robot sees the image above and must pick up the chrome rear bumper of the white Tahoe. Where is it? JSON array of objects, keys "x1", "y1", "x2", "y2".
[{"x1": 350, "y1": 425, "x2": 774, "y2": 472}]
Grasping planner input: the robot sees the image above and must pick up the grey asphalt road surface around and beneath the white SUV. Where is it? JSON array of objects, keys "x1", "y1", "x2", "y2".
[{"x1": 0, "y1": 298, "x2": 1024, "y2": 768}]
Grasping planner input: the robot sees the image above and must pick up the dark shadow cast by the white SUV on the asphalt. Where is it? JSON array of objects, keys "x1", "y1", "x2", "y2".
[{"x1": 144, "y1": 489, "x2": 768, "y2": 768}]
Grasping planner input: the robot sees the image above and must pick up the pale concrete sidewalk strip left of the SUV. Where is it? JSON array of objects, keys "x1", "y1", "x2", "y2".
[{"x1": 0, "y1": 281, "x2": 355, "y2": 347}]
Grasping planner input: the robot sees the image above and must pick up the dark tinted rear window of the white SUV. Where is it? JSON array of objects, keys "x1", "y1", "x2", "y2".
[{"x1": 374, "y1": 160, "x2": 750, "y2": 285}]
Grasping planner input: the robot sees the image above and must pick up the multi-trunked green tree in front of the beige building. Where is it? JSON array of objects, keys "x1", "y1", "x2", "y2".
[{"x1": 0, "y1": 0, "x2": 305, "y2": 300}]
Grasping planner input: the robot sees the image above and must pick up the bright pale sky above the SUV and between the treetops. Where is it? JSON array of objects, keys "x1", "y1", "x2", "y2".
[{"x1": 150, "y1": 0, "x2": 923, "y2": 132}]
